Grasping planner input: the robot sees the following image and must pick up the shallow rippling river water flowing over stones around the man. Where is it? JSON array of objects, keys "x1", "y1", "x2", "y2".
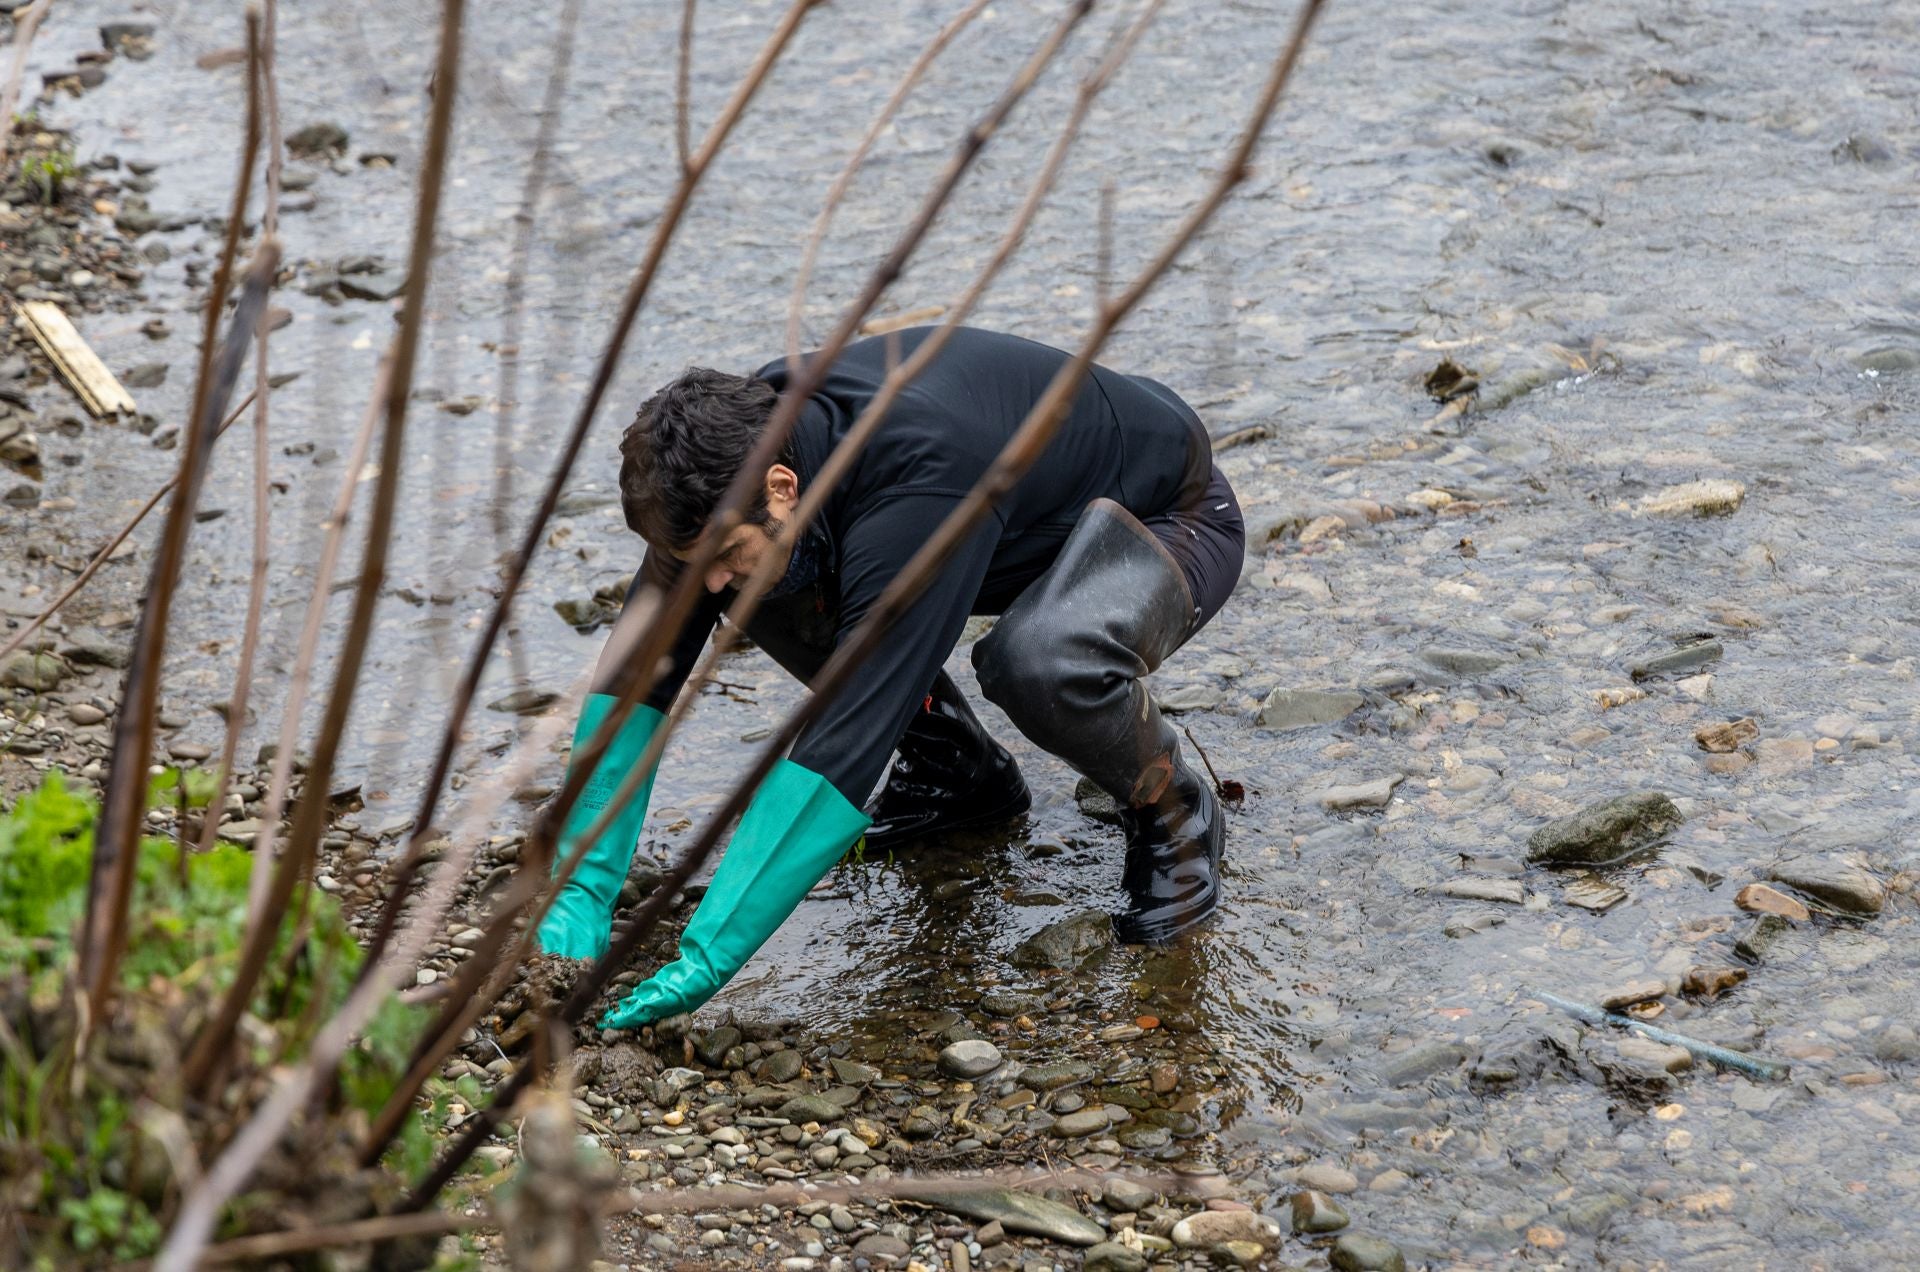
[{"x1": 6, "y1": 0, "x2": 1920, "y2": 1268}]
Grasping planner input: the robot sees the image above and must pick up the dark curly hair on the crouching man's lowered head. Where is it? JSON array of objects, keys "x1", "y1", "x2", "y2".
[{"x1": 620, "y1": 367, "x2": 793, "y2": 551}]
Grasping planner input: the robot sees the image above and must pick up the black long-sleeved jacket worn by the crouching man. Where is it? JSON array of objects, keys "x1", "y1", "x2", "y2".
[{"x1": 637, "y1": 327, "x2": 1212, "y2": 807}]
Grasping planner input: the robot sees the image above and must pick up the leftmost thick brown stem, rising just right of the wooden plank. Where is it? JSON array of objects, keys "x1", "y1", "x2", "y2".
[{"x1": 79, "y1": 13, "x2": 266, "y2": 1020}]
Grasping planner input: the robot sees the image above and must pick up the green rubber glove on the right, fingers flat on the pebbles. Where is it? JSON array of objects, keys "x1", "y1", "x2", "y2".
[{"x1": 601, "y1": 759, "x2": 872, "y2": 1030}]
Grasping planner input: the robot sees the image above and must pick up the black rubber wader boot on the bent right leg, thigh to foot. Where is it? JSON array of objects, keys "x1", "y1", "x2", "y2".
[{"x1": 973, "y1": 500, "x2": 1225, "y2": 943}]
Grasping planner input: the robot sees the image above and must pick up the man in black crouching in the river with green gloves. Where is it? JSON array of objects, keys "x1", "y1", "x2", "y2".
[{"x1": 540, "y1": 329, "x2": 1246, "y2": 1028}]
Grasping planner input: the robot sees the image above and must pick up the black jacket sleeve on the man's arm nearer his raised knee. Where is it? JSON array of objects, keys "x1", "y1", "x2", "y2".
[{"x1": 791, "y1": 494, "x2": 1000, "y2": 807}]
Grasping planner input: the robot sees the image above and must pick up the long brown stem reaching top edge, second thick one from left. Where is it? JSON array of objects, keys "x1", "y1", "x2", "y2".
[{"x1": 182, "y1": 0, "x2": 467, "y2": 1106}]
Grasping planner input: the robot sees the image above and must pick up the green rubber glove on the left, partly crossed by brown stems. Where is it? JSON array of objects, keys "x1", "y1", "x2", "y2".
[{"x1": 540, "y1": 694, "x2": 666, "y2": 959}]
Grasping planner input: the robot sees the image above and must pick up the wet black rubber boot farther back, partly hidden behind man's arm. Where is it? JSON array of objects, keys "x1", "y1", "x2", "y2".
[{"x1": 866, "y1": 671, "x2": 1033, "y2": 851}]
